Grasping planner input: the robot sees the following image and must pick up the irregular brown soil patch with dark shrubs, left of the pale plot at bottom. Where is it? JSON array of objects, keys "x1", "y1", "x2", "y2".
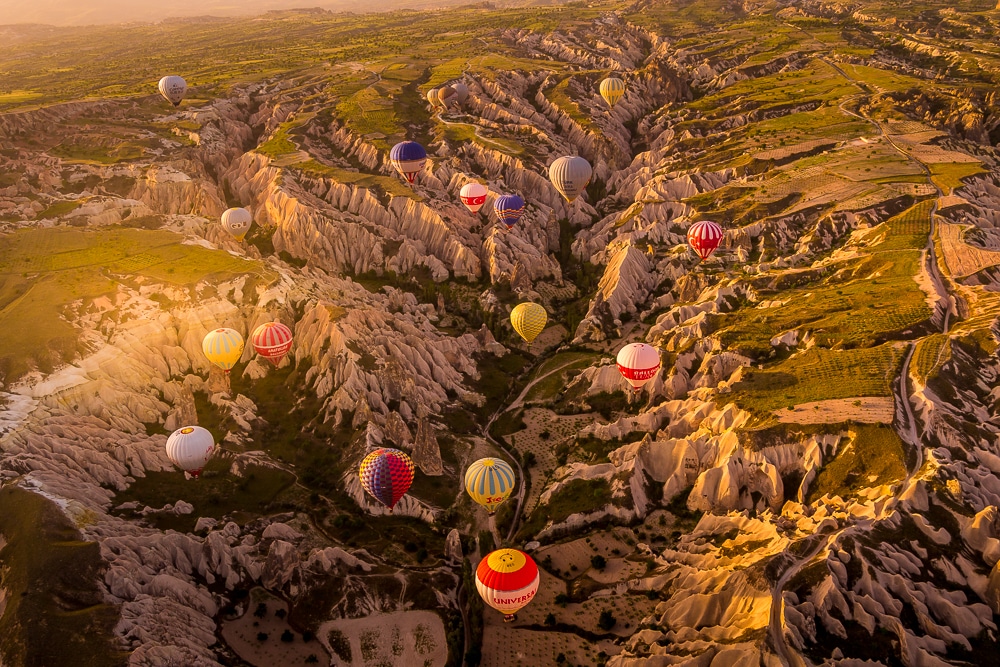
[{"x1": 222, "y1": 588, "x2": 330, "y2": 667}]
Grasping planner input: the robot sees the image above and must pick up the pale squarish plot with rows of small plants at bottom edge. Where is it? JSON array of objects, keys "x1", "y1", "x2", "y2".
[{"x1": 318, "y1": 611, "x2": 448, "y2": 667}]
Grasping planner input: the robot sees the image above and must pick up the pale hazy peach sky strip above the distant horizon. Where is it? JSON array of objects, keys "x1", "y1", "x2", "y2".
[{"x1": 0, "y1": 0, "x2": 488, "y2": 25}]
